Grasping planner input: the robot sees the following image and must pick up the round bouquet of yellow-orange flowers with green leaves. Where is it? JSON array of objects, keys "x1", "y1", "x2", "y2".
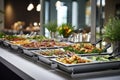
[{"x1": 58, "y1": 23, "x2": 73, "y2": 38}]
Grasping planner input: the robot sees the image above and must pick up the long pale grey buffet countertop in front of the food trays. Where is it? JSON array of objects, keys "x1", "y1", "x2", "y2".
[{"x1": 0, "y1": 48, "x2": 120, "y2": 80}]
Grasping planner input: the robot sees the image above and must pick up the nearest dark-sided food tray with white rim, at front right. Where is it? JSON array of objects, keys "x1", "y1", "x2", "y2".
[{"x1": 51, "y1": 55, "x2": 120, "y2": 74}]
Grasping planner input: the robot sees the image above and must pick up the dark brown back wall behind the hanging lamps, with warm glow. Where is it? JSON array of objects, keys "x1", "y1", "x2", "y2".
[{"x1": 4, "y1": 0, "x2": 40, "y2": 29}]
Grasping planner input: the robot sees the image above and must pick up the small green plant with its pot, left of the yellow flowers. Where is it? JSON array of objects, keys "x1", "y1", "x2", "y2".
[{"x1": 44, "y1": 22, "x2": 57, "y2": 38}]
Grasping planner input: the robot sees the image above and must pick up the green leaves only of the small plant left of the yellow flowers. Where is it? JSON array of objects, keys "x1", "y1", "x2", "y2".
[{"x1": 44, "y1": 22, "x2": 57, "y2": 32}]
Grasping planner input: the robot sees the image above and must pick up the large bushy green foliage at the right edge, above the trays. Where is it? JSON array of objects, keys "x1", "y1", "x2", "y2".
[{"x1": 103, "y1": 17, "x2": 120, "y2": 42}]
